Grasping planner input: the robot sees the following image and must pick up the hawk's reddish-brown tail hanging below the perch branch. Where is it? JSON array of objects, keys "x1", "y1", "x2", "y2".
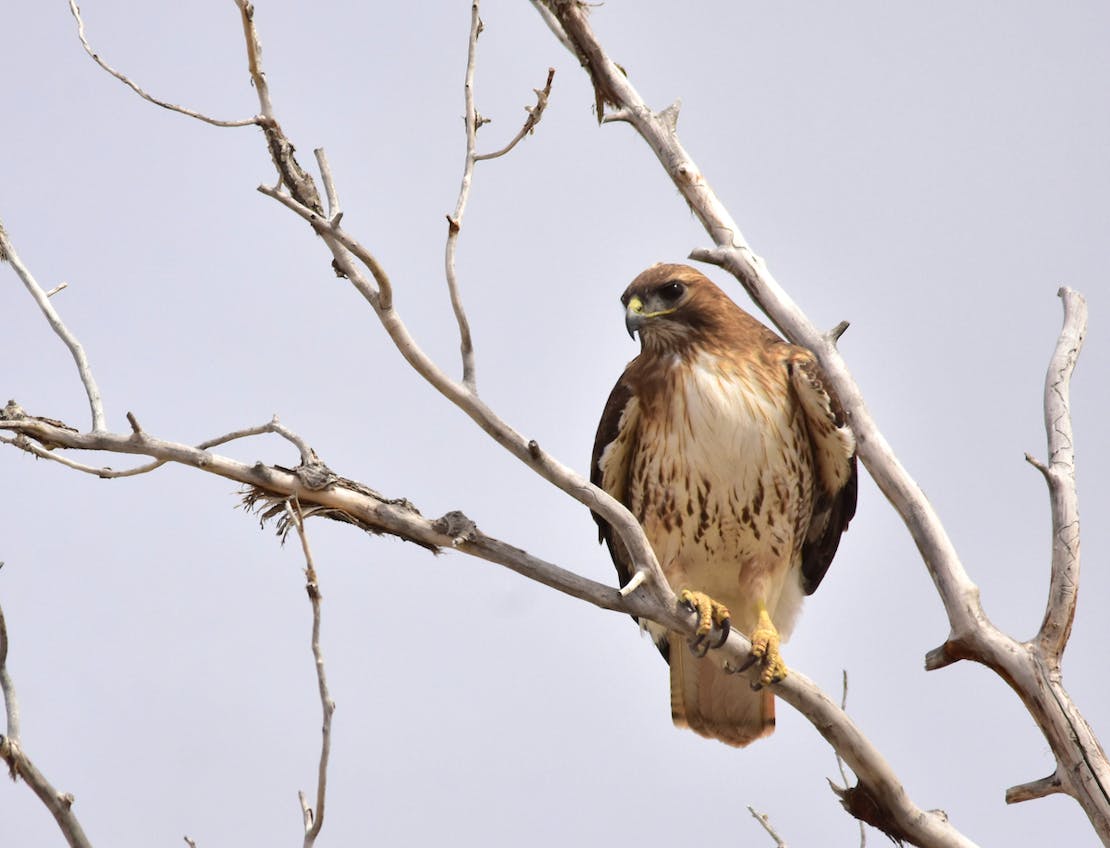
[{"x1": 669, "y1": 634, "x2": 775, "y2": 748}]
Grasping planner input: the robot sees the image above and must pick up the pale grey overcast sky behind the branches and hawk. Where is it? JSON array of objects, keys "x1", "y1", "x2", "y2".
[{"x1": 0, "y1": 0, "x2": 1110, "y2": 848}]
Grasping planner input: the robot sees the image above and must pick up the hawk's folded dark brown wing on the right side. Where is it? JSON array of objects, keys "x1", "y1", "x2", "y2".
[{"x1": 789, "y1": 350, "x2": 857, "y2": 595}]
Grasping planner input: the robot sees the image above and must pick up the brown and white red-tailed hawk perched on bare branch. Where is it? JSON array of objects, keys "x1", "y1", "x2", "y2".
[{"x1": 591, "y1": 264, "x2": 856, "y2": 746}]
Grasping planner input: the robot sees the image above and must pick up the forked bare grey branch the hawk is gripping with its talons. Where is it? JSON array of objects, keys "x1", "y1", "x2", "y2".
[{"x1": 36, "y1": 0, "x2": 970, "y2": 846}]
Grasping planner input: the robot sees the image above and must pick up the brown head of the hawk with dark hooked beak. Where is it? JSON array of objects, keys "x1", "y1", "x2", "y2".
[{"x1": 620, "y1": 264, "x2": 739, "y2": 352}]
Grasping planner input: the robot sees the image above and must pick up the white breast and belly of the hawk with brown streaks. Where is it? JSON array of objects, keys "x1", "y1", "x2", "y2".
[{"x1": 630, "y1": 356, "x2": 813, "y2": 633}]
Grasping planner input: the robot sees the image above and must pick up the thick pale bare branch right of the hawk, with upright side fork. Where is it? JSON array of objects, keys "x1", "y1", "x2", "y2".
[{"x1": 533, "y1": 0, "x2": 1110, "y2": 845}]
